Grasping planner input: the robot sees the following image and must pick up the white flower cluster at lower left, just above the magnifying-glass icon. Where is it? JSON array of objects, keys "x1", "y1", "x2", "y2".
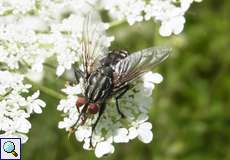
[{"x1": 0, "y1": 71, "x2": 46, "y2": 143}]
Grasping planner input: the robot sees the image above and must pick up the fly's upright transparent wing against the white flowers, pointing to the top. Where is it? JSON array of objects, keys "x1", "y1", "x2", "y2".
[{"x1": 81, "y1": 12, "x2": 109, "y2": 77}]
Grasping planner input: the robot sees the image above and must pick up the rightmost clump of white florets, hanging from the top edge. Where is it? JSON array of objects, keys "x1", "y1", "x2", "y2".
[{"x1": 145, "y1": 0, "x2": 200, "y2": 36}]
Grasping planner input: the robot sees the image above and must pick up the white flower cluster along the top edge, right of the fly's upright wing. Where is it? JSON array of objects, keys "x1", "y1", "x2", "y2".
[{"x1": 101, "y1": 0, "x2": 201, "y2": 36}]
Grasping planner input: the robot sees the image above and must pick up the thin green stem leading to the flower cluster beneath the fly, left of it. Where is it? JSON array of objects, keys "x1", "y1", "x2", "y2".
[{"x1": 25, "y1": 77, "x2": 66, "y2": 99}]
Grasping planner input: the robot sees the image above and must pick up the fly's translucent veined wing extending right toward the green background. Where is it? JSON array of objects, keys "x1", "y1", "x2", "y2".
[{"x1": 113, "y1": 47, "x2": 171, "y2": 88}]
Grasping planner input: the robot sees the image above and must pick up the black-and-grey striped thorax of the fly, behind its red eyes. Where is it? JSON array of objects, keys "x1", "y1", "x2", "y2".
[{"x1": 85, "y1": 66, "x2": 113, "y2": 103}]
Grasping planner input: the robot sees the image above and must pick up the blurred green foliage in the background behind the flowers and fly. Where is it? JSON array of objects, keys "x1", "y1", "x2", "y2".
[{"x1": 23, "y1": 0, "x2": 230, "y2": 160}]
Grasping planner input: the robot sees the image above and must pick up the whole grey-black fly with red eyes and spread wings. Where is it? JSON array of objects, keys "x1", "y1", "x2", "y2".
[{"x1": 68, "y1": 13, "x2": 171, "y2": 147}]
